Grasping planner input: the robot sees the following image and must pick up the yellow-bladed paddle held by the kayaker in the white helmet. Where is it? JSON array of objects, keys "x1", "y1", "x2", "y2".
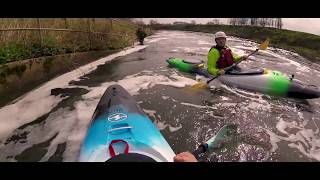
[{"x1": 191, "y1": 39, "x2": 269, "y2": 89}]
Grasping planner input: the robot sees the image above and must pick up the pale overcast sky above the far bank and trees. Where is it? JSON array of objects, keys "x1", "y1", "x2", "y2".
[{"x1": 142, "y1": 18, "x2": 320, "y2": 35}]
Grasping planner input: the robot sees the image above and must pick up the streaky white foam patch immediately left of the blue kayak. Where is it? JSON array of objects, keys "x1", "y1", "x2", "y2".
[{"x1": 0, "y1": 102, "x2": 94, "y2": 161}]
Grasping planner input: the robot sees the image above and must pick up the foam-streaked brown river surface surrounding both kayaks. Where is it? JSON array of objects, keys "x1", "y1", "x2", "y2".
[{"x1": 0, "y1": 31, "x2": 320, "y2": 162}]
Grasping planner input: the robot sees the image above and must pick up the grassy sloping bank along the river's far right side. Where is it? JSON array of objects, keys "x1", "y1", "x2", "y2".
[{"x1": 152, "y1": 24, "x2": 320, "y2": 62}]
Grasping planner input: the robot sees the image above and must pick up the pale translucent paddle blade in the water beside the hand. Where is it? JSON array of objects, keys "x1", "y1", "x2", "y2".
[{"x1": 192, "y1": 124, "x2": 236, "y2": 159}]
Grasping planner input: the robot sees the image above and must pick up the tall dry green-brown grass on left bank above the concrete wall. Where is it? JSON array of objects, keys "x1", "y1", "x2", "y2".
[{"x1": 0, "y1": 18, "x2": 152, "y2": 64}]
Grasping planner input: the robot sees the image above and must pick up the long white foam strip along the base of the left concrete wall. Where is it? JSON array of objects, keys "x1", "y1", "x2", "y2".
[{"x1": 0, "y1": 46, "x2": 147, "y2": 138}]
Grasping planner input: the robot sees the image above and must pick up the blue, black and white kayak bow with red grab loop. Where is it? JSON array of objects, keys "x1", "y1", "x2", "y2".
[{"x1": 79, "y1": 85, "x2": 175, "y2": 162}]
